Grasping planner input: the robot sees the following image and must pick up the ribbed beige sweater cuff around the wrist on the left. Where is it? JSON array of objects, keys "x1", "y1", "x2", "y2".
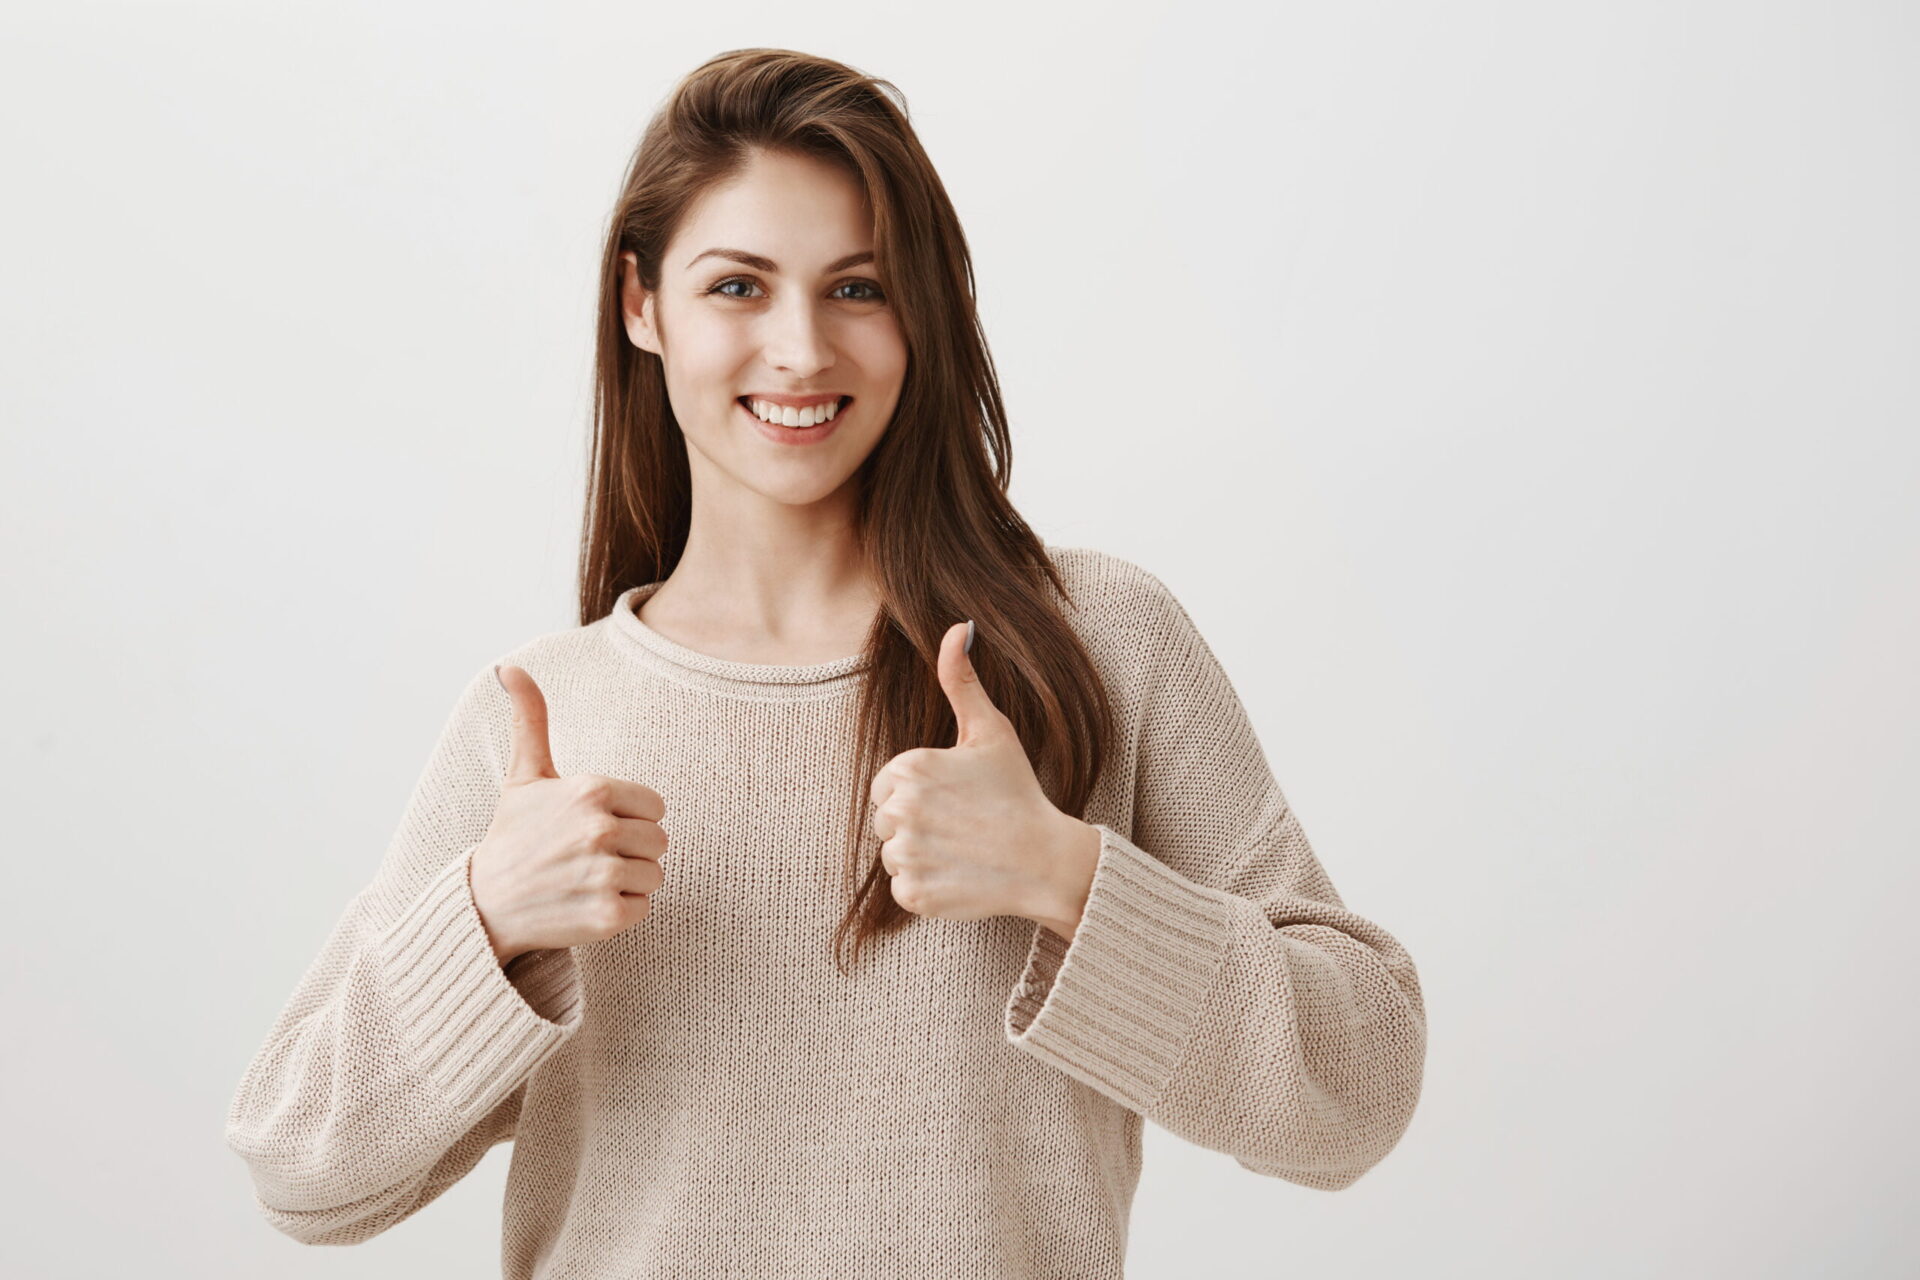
[{"x1": 374, "y1": 848, "x2": 582, "y2": 1119}]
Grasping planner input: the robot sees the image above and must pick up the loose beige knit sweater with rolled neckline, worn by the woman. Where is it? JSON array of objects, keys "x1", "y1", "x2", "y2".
[{"x1": 227, "y1": 547, "x2": 1427, "y2": 1280}]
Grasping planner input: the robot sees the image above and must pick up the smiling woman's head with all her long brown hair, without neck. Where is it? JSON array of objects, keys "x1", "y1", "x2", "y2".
[{"x1": 580, "y1": 48, "x2": 1112, "y2": 960}]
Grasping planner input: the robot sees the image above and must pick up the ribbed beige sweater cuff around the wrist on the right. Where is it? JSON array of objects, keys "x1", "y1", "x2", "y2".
[{"x1": 1006, "y1": 823, "x2": 1233, "y2": 1113}]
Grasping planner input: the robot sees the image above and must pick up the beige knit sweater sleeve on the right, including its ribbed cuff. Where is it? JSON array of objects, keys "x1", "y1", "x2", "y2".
[{"x1": 1006, "y1": 570, "x2": 1427, "y2": 1192}]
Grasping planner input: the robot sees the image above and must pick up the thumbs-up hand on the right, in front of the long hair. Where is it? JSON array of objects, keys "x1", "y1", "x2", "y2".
[{"x1": 868, "y1": 622, "x2": 1100, "y2": 938}]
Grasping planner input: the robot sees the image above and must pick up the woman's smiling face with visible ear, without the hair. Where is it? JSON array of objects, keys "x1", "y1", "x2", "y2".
[{"x1": 622, "y1": 152, "x2": 906, "y2": 505}]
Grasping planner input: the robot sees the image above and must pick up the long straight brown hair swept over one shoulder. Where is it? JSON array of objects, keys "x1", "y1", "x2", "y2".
[{"x1": 580, "y1": 48, "x2": 1112, "y2": 973}]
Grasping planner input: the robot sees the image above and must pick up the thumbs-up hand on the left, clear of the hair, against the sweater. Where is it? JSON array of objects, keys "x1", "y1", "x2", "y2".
[{"x1": 470, "y1": 666, "x2": 666, "y2": 963}]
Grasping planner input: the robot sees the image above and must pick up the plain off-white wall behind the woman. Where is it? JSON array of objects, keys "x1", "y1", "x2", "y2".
[{"x1": 0, "y1": 0, "x2": 1920, "y2": 1280}]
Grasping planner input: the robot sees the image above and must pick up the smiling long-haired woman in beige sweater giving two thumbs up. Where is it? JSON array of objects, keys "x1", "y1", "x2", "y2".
[{"x1": 227, "y1": 50, "x2": 1427, "y2": 1280}]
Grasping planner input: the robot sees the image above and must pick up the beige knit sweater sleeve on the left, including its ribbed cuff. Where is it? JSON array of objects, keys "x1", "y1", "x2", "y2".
[{"x1": 227, "y1": 666, "x2": 582, "y2": 1244}]
